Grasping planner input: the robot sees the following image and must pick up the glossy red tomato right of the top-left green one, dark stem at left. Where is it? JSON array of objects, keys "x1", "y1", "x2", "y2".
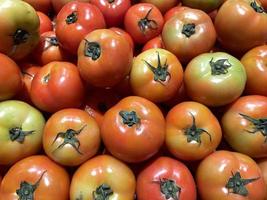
[{"x1": 55, "y1": 1, "x2": 106, "y2": 55}]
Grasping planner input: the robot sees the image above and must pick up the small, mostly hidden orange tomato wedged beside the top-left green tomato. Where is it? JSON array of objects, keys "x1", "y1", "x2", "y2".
[{"x1": 33, "y1": 31, "x2": 71, "y2": 65}]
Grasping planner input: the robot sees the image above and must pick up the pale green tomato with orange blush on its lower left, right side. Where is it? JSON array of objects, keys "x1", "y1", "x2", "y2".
[{"x1": 184, "y1": 52, "x2": 246, "y2": 106}]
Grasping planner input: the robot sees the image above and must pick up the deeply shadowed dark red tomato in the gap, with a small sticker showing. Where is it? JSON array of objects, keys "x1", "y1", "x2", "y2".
[{"x1": 83, "y1": 88, "x2": 120, "y2": 126}]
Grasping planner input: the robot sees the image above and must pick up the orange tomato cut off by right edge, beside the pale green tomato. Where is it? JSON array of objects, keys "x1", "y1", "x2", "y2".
[{"x1": 241, "y1": 45, "x2": 267, "y2": 96}]
